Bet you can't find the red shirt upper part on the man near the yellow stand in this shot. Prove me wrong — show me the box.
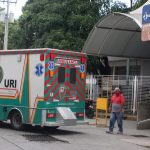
[111,93,125,105]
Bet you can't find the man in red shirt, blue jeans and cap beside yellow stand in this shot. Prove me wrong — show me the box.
[106,87,125,134]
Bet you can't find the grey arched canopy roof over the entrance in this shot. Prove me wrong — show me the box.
[83,10,150,59]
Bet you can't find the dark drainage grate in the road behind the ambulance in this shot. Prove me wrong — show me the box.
[22,134,69,143]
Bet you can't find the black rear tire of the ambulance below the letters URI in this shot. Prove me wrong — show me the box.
[10,111,23,130]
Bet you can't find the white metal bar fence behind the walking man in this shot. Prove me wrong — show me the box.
[86,75,150,113]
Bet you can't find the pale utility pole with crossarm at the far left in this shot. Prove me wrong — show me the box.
[0,0,17,50]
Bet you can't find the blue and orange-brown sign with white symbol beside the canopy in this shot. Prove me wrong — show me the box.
[141,4,150,41]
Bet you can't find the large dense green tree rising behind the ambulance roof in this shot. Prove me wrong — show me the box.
[13,0,110,51]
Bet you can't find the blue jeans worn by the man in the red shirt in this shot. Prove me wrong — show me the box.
[109,112,123,132]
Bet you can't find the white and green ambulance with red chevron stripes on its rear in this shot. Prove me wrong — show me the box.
[0,48,87,130]
